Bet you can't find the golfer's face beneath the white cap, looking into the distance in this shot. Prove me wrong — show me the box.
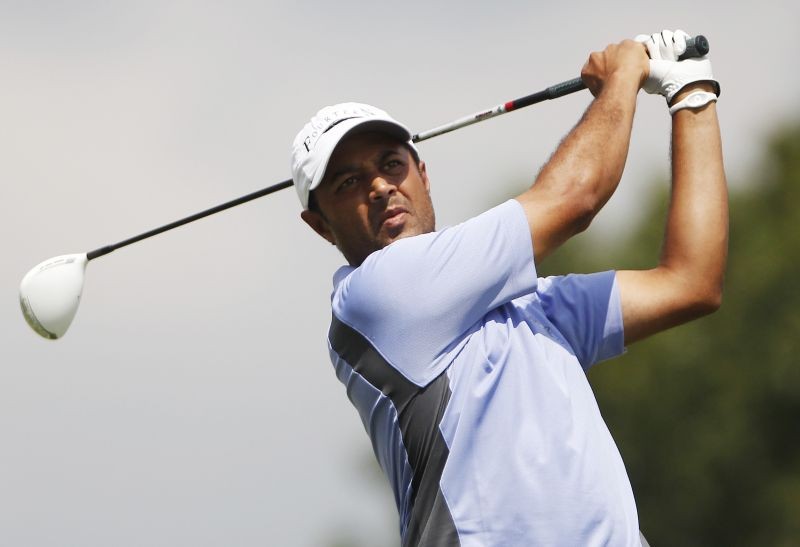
[314,133,434,264]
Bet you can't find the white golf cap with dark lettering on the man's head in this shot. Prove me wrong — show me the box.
[292,103,416,209]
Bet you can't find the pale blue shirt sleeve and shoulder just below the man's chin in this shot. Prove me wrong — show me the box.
[332,200,537,386]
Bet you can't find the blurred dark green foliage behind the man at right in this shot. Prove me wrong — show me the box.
[544,120,800,547]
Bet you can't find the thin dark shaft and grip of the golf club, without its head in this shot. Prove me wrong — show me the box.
[86,35,709,260]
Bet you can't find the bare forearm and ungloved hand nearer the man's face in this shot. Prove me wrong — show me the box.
[516,40,648,261]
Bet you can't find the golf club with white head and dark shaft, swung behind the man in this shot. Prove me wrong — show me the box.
[19,35,709,340]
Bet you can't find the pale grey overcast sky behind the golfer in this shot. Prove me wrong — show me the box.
[0,0,800,547]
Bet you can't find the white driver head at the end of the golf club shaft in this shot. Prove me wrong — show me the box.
[19,254,88,340]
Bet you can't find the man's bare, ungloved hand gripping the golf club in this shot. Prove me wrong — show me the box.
[581,40,648,97]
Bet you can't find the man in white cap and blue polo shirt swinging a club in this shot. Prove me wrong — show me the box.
[292,31,727,547]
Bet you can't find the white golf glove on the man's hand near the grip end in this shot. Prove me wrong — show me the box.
[634,30,720,104]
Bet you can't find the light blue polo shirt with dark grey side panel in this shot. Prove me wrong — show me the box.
[328,200,640,547]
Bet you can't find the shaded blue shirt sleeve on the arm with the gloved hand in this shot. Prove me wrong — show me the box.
[537,271,625,370]
